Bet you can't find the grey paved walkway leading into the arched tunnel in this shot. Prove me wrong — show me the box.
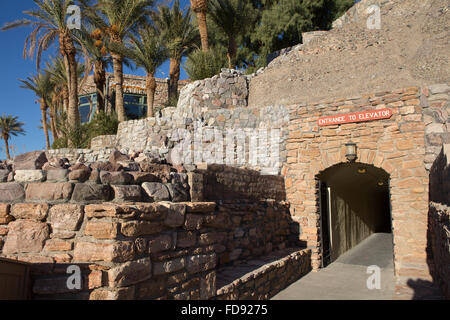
[273,233,395,300]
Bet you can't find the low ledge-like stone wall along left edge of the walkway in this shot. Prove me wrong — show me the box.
[216,248,311,300]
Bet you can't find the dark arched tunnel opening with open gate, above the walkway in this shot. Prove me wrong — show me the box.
[318,163,392,267]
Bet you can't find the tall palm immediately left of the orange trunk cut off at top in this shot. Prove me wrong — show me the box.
[153,0,199,101]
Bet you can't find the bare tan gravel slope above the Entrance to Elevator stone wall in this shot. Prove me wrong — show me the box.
[249,0,450,106]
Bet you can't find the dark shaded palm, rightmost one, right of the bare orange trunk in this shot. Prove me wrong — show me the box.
[209,0,250,69]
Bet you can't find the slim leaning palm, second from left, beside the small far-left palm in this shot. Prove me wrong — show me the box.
[19,71,55,149]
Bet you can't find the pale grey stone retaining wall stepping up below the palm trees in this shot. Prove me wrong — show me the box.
[83,69,289,174]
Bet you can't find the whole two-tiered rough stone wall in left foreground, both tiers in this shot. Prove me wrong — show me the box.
[0,151,309,300]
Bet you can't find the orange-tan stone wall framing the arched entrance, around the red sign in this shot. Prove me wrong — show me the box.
[283,87,430,281]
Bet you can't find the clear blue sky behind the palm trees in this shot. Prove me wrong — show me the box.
[0,0,189,159]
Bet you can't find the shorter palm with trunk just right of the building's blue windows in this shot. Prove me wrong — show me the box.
[118,26,168,118]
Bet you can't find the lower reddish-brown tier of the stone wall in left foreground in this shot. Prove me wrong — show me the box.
[0,198,298,299]
